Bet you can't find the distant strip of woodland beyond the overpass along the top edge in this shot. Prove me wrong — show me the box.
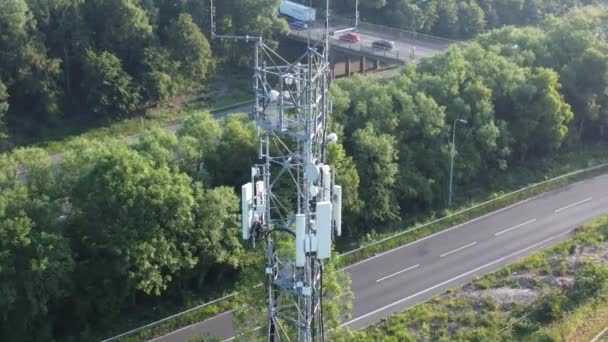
[320,0,600,39]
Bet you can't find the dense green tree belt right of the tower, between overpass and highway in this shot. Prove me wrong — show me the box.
[332,7,608,236]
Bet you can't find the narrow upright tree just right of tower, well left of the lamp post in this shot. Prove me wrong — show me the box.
[352,124,399,230]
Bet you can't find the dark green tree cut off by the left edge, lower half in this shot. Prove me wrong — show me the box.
[0,150,74,341]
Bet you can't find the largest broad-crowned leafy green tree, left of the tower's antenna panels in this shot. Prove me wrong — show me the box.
[68,145,197,322]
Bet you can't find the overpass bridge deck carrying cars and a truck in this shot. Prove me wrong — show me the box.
[288,17,460,65]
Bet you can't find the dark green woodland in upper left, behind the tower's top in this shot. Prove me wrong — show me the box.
[0,0,287,146]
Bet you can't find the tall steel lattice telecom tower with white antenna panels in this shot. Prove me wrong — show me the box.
[211,0,342,342]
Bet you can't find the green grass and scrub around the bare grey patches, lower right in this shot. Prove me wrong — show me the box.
[333,217,608,342]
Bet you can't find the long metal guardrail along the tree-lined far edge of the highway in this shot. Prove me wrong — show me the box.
[102,163,608,342]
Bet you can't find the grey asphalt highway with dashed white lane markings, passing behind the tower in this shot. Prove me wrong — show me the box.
[152,175,608,342]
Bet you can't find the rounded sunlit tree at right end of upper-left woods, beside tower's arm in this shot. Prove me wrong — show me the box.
[167,14,213,85]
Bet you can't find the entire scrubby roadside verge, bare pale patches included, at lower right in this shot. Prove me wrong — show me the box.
[332,217,608,341]
